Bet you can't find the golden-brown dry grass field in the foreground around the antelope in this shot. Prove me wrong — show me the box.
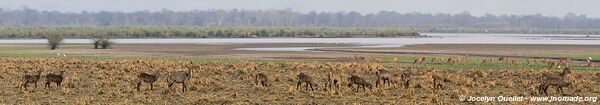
[0,58,600,104]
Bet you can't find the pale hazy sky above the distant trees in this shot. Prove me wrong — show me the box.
[0,0,600,18]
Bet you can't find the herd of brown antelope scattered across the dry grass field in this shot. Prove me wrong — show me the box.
[21,56,594,95]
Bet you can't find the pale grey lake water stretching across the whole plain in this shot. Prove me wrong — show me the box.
[0,33,600,51]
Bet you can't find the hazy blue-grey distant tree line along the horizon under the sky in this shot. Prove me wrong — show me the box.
[0,7,600,30]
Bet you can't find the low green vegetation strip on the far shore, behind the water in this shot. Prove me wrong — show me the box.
[0,26,420,38]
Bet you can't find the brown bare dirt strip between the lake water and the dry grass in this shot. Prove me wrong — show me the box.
[0,43,600,61]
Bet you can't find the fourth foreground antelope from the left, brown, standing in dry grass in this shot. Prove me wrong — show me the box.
[167,69,192,92]
